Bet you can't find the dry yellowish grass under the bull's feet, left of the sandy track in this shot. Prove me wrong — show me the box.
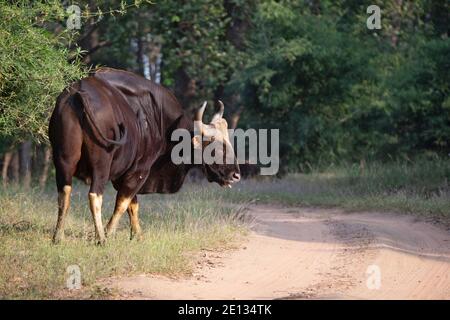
[0,185,245,299]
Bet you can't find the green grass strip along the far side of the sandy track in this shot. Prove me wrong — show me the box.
[225,160,450,223]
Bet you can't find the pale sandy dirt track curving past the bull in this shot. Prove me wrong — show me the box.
[108,206,450,299]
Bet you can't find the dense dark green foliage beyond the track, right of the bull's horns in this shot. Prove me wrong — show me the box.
[234,1,450,170]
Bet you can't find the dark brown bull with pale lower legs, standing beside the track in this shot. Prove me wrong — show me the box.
[49,68,240,243]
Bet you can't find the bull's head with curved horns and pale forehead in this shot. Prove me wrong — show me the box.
[192,101,241,188]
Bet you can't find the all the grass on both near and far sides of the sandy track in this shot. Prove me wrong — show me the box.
[0,160,450,298]
